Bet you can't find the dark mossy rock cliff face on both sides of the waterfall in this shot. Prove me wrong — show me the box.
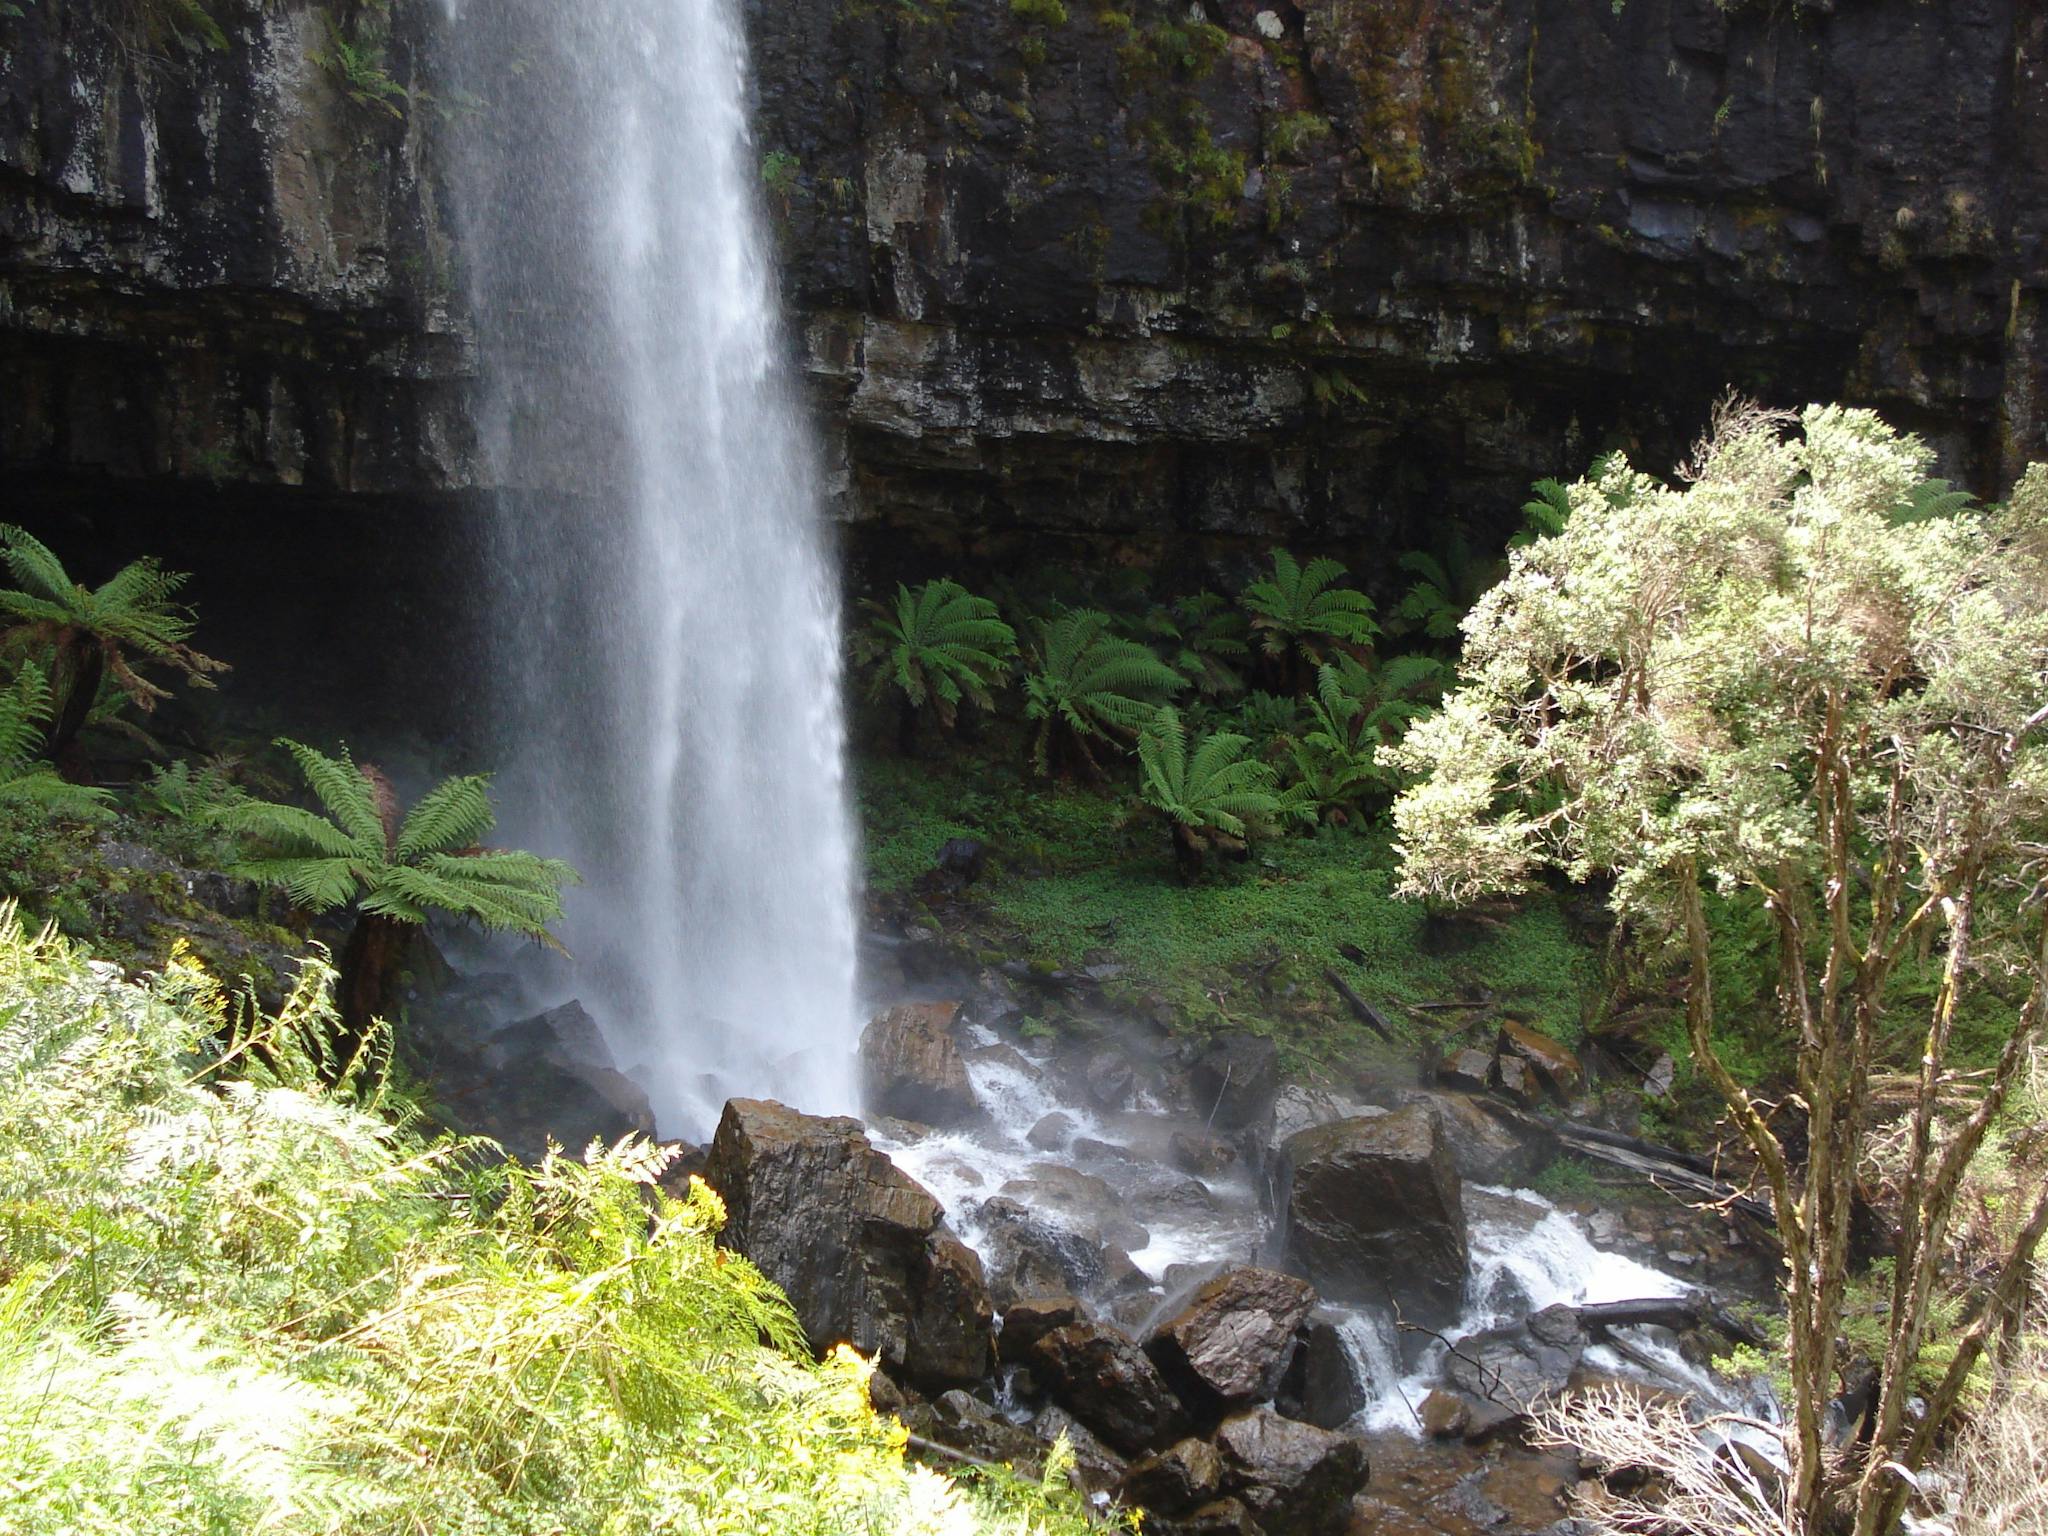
[0,0,2048,555]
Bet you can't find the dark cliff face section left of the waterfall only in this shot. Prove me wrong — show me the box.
[0,0,469,500]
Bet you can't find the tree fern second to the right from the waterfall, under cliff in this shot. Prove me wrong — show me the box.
[1024,608,1186,776]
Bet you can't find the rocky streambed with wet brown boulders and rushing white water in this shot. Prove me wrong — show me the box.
[395,933,1769,1536]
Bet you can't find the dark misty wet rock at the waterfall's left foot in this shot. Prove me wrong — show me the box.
[465,1001,653,1161]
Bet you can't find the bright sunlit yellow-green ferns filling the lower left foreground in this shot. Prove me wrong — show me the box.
[0,905,1100,1536]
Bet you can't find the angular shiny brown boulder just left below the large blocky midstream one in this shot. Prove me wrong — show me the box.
[1145,1268,1315,1419]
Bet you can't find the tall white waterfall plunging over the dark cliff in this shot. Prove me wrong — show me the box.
[442,0,856,1137]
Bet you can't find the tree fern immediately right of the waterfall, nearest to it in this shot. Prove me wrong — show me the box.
[856,580,1018,729]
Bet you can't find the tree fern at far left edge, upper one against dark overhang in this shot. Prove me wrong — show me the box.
[0,524,225,758]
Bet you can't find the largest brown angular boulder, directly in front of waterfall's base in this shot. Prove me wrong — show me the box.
[705,1098,995,1391]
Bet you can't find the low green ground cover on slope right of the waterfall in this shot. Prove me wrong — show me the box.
[858,758,1597,1065]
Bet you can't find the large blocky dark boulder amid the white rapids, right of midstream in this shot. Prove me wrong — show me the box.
[1280,1102,1468,1327]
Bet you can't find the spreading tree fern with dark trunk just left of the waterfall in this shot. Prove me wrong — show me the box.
[221,739,575,1034]
